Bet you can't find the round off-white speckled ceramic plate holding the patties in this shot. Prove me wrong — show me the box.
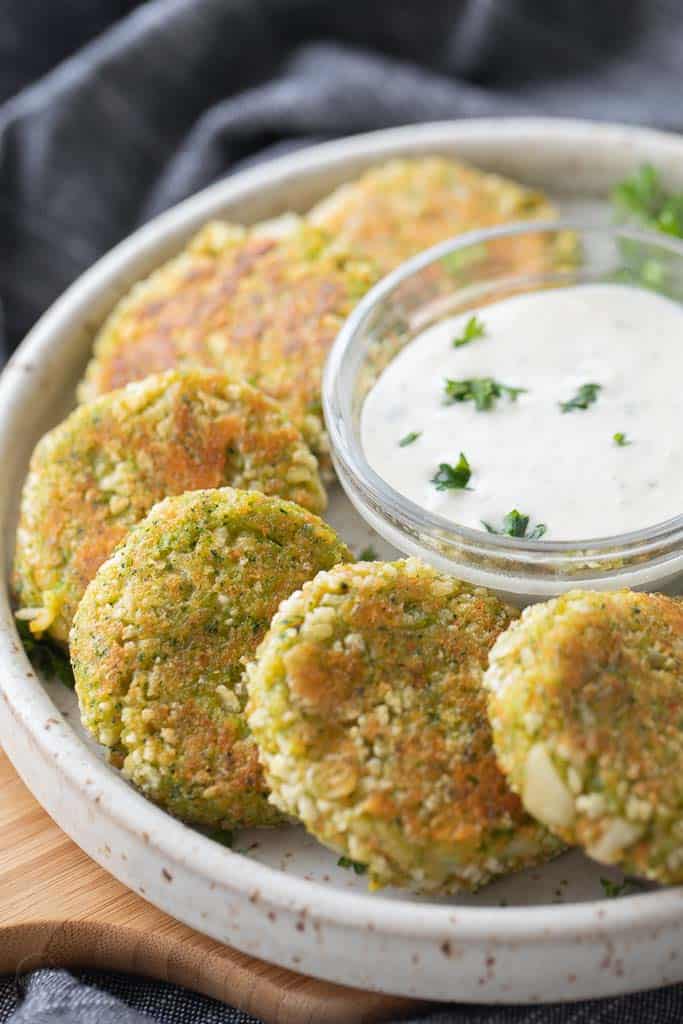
[0,119,683,1002]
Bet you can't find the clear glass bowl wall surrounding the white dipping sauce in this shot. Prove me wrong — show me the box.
[323,221,683,604]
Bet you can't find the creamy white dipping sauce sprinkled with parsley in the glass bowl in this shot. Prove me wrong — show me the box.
[361,285,683,540]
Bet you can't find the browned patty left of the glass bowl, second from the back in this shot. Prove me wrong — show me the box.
[80,222,378,468]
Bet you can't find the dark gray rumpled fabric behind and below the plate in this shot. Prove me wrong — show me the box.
[0,0,683,1024]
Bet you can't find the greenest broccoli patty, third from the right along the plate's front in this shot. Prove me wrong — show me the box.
[71,487,350,828]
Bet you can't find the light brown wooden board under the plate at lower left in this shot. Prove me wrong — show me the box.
[0,751,426,1024]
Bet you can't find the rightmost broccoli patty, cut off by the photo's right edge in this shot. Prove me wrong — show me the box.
[485,590,683,883]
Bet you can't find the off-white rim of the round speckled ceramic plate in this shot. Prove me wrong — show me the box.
[0,118,683,995]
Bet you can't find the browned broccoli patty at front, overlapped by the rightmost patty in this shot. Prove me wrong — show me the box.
[248,558,560,892]
